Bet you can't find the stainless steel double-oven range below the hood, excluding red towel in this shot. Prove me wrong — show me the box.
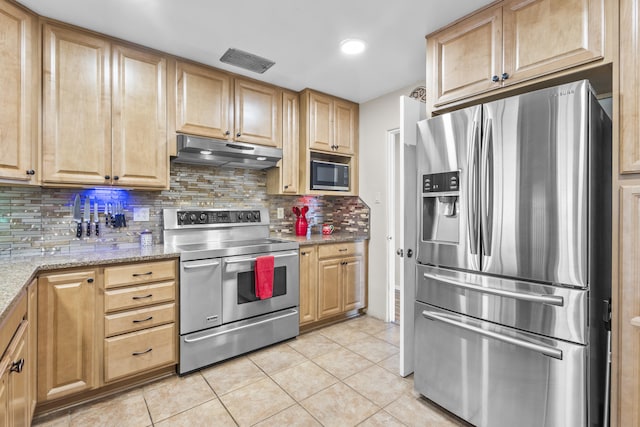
[163,209,299,374]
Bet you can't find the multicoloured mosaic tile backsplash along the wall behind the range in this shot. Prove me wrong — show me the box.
[0,164,369,257]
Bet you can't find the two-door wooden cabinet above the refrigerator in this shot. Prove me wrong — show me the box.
[427,0,613,108]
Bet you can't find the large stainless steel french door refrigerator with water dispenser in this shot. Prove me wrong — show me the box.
[414,80,611,427]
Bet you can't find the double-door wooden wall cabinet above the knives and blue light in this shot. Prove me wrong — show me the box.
[42,23,169,188]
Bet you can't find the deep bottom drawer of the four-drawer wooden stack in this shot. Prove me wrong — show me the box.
[104,323,176,382]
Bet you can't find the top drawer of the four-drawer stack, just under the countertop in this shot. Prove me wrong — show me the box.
[104,261,176,288]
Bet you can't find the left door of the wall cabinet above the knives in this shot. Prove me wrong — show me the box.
[42,24,111,185]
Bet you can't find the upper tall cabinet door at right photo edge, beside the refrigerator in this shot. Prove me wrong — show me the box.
[618,0,640,173]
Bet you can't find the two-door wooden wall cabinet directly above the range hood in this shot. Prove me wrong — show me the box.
[175,61,282,147]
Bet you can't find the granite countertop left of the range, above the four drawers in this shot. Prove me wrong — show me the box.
[0,245,180,323]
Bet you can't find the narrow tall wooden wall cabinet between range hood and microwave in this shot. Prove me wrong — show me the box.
[267,91,300,194]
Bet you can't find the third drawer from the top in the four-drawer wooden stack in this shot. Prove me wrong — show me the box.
[104,303,176,337]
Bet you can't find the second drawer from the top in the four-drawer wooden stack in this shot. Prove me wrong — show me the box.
[104,280,176,313]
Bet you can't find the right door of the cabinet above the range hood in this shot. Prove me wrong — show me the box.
[233,79,282,147]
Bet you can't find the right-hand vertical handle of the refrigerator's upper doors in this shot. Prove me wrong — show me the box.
[480,119,493,256]
